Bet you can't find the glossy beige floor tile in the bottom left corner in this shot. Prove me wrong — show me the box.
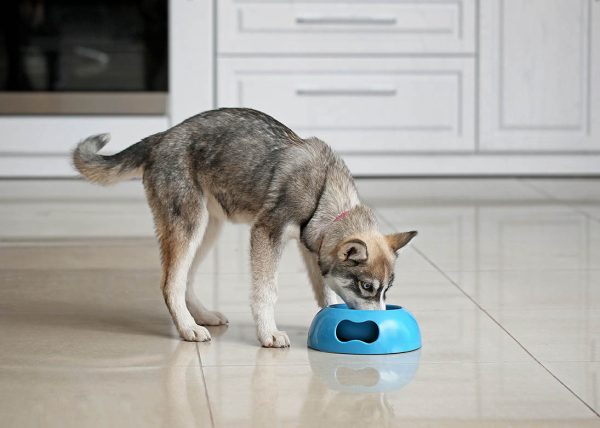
[0,348,212,428]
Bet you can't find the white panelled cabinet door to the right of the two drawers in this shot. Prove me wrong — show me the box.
[480,0,600,152]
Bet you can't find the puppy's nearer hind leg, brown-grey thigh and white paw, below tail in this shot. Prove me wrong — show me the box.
[144,172,210,342]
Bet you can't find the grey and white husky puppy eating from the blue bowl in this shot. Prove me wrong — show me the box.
[73,108,417,348]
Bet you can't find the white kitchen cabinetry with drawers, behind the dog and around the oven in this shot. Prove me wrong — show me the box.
[0,0,600,176]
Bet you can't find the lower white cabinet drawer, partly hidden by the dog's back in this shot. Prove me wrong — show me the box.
[218,58,474,153]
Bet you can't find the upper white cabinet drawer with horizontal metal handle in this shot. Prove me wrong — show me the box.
[217,0,475,54]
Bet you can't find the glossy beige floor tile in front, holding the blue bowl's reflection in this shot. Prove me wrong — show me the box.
[204,362,598,427]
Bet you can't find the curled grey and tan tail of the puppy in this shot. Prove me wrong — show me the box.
[73,134,150,186]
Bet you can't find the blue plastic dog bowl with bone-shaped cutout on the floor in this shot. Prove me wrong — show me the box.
[308,304,421,355]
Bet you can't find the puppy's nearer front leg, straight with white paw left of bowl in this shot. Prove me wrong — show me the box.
[250,224,290,348]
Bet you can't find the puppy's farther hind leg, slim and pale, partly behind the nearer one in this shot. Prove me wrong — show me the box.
[185,215,228,325]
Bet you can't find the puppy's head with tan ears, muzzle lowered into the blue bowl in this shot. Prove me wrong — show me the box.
[323,230,417,310]
